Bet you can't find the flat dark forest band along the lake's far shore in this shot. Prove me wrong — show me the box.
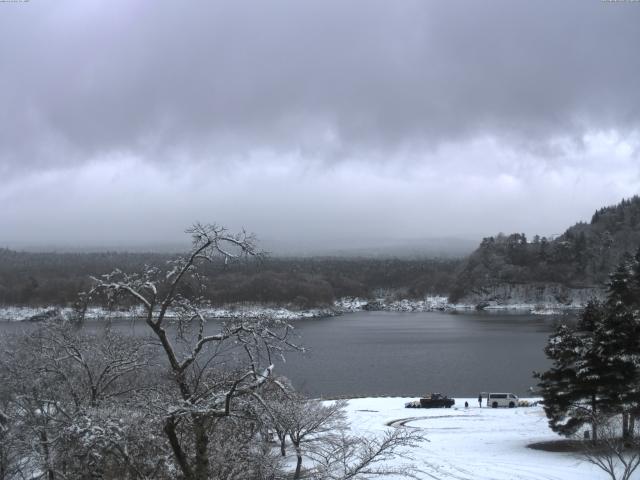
[0,249,461,307]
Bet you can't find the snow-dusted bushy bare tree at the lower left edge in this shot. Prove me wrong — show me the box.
[0,323,155,480]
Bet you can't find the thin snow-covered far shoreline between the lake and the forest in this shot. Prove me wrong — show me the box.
[0,296,583,321]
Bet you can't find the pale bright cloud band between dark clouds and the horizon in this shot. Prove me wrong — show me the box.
[0,136,640,252]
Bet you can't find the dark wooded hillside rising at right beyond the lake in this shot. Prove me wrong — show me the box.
[451,196,640,301]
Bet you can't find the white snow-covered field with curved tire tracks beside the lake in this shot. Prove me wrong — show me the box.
[348,398,604,480]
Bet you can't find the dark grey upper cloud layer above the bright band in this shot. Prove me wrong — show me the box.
[0,0,640,174]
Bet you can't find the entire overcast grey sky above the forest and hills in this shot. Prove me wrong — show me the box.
[0,0,640,250]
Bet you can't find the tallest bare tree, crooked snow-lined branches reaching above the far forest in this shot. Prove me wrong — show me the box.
[83,224,293,480]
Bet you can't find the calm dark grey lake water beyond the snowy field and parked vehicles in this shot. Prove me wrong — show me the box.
[0,312,558,397]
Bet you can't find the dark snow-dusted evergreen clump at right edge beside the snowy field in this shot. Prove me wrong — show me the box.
[536,250,640,440]
